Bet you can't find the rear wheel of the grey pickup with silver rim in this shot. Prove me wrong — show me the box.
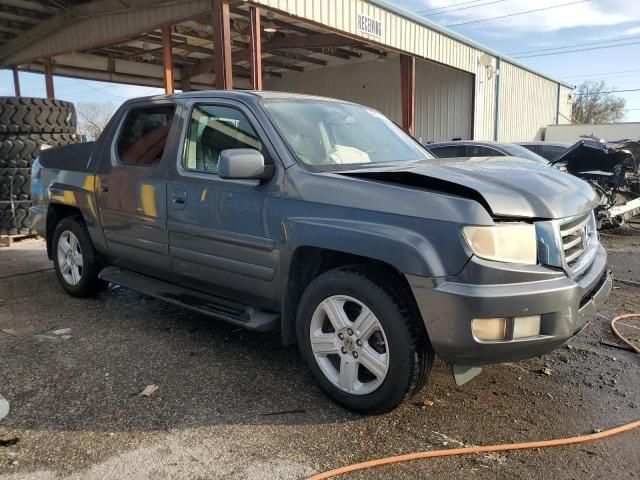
[52,217,104,297]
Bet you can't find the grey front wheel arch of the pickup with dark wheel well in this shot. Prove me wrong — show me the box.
[280,219,443,345]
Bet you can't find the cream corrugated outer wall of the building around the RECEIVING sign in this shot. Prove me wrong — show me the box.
[253,0,571,141]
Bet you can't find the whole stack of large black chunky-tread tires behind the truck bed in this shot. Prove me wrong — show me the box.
[0,97,80,235]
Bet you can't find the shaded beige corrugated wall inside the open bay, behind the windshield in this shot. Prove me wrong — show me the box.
[265,56,474,141]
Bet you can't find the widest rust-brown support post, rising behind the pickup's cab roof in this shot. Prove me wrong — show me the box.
[212,0,233,90]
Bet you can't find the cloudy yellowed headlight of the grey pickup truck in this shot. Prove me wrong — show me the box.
[463,224,538,265]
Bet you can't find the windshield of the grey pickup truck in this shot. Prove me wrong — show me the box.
[264,99,433,169]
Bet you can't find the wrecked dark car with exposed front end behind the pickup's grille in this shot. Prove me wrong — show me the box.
[552,138,640,228]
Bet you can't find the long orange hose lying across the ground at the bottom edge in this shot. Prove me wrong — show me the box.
[308,420,640,480]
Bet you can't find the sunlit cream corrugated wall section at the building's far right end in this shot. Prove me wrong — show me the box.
[498,61,558,142]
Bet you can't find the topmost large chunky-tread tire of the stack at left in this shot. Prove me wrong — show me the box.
[0,97,78,133]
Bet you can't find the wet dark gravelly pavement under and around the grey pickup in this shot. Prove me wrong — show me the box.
[0,229,640,480]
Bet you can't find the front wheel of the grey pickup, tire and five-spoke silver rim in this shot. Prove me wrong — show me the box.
[296,267,433,413]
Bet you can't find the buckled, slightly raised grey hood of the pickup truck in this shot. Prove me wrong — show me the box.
[335,157,598,219]
